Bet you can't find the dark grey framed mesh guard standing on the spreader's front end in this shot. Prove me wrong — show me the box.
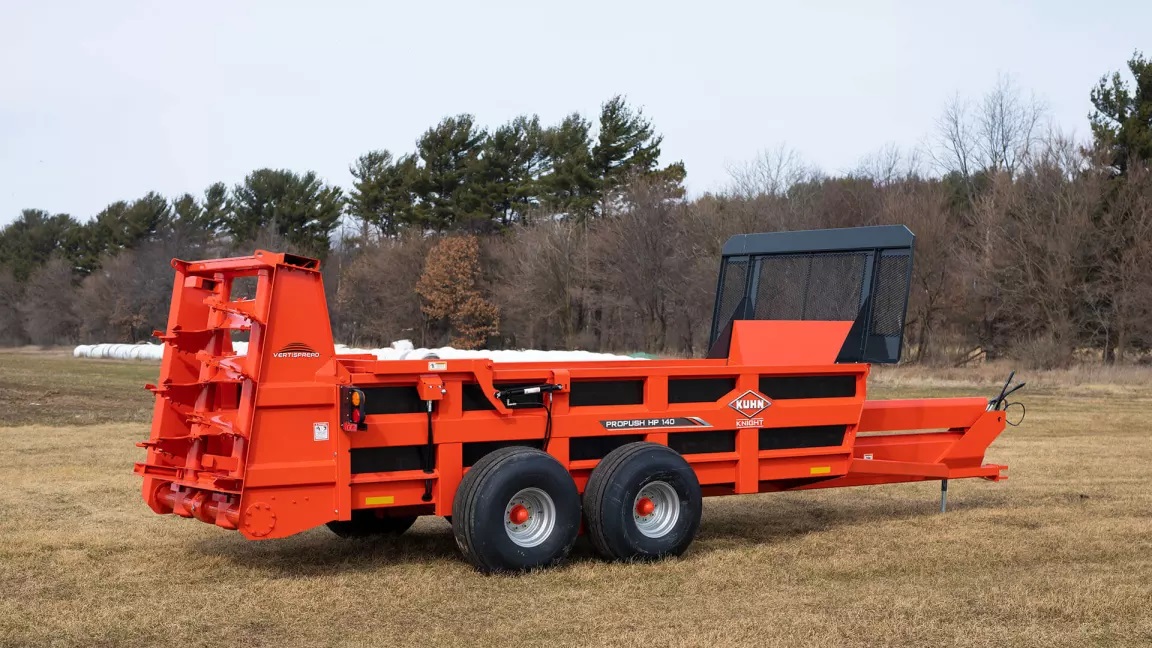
[708,226,915,364]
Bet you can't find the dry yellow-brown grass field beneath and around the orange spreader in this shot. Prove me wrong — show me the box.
[0,352,1152,647]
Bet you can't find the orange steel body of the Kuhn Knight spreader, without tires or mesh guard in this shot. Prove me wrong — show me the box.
[136,251,1006,538]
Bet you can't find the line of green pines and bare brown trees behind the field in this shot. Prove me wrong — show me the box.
[0,53,1152,366]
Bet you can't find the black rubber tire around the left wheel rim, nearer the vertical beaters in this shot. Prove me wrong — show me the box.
[452,446,581,573]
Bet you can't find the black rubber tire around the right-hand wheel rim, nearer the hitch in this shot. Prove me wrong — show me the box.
[584,442,703,560]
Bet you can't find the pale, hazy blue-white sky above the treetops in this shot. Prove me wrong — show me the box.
[0,0,1152,224]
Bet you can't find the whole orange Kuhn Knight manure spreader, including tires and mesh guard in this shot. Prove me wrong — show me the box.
[136,226,1009,572]
